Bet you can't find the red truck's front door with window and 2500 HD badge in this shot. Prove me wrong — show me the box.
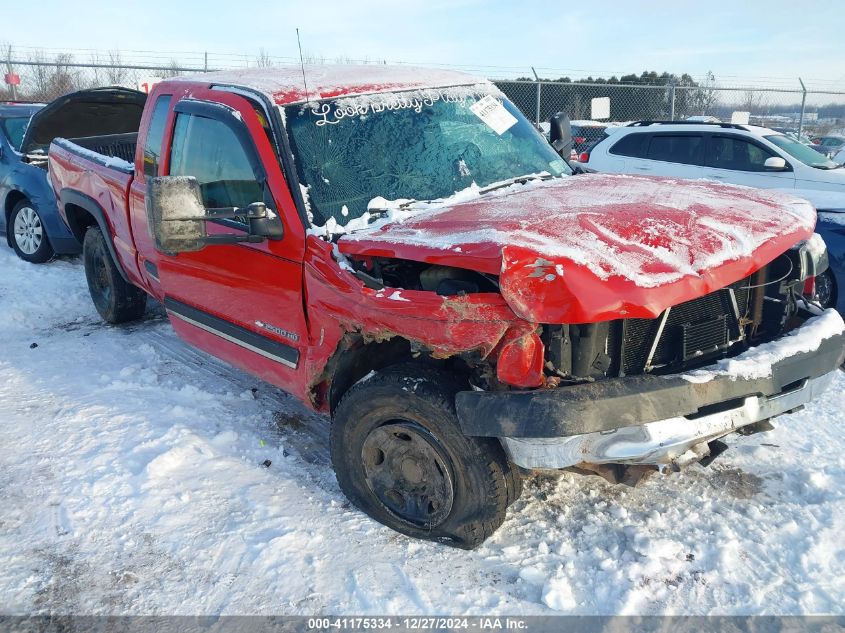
[142,90,308,389]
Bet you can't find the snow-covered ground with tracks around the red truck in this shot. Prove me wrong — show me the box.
[0,248,845,615]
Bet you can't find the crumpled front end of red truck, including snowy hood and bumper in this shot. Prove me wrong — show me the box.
[312,172,845,479]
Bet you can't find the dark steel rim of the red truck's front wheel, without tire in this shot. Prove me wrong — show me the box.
[361,421,455,529]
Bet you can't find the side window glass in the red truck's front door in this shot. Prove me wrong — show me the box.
[170,114,264,209]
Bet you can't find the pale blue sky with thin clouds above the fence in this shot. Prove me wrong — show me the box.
[0,0,845,89]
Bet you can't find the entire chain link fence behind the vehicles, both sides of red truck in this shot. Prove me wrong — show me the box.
[0,46,845,135]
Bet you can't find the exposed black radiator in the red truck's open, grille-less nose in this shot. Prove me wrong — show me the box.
[621,279,750,375]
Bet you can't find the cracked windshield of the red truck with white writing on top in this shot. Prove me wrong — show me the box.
[285,85,571,226]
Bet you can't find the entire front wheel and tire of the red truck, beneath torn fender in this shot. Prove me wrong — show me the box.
[331,365,522,549]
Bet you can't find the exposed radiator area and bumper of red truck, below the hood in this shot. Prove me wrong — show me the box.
[457,235,845,476]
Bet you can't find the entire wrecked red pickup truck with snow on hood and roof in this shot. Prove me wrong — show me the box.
[49,66,845,547]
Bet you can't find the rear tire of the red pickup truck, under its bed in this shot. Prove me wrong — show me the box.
[82,226,147,324]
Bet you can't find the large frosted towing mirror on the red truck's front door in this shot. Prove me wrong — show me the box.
[146,176,284,253]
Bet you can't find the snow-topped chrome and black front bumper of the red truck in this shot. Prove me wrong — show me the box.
[456,310,845,468]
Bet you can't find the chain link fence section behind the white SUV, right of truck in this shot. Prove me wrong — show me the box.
[496,81,845,135]
